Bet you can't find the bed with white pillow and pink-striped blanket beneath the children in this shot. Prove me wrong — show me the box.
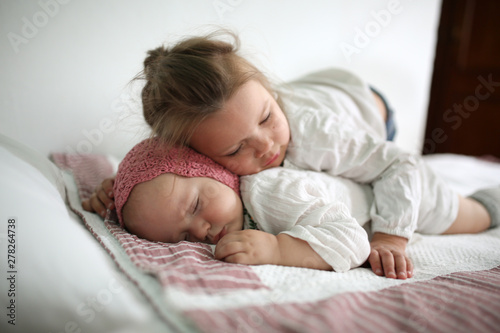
[0,131,500,332]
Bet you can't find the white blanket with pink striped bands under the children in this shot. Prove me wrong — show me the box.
[53,154,500,332]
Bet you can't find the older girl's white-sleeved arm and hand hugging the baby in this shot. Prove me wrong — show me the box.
[292,126,423,279]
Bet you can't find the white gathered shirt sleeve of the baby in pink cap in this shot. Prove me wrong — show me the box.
[241,168,370,272]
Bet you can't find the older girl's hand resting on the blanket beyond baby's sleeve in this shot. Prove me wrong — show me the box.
[368,232,413,280]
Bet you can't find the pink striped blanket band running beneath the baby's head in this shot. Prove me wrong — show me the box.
[52,154,266,294]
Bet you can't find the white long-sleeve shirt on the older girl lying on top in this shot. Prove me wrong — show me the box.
[278,69,422,238]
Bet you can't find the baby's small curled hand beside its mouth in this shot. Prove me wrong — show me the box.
[215,230,281,265]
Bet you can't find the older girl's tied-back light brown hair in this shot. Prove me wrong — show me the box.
[138,31,273,147]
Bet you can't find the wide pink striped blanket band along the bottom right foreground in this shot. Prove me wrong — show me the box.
[186,267,500,332]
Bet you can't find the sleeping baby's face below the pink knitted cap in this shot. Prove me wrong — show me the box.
[123,173,243,244]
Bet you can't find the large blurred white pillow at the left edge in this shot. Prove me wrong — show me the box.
[0,135,169,332]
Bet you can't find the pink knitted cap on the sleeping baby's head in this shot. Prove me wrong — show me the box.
[113,138,240,227]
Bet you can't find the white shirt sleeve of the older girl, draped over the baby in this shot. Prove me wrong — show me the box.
[290,117,422,238]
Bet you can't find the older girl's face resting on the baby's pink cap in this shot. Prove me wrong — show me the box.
[190,80,290,176]
